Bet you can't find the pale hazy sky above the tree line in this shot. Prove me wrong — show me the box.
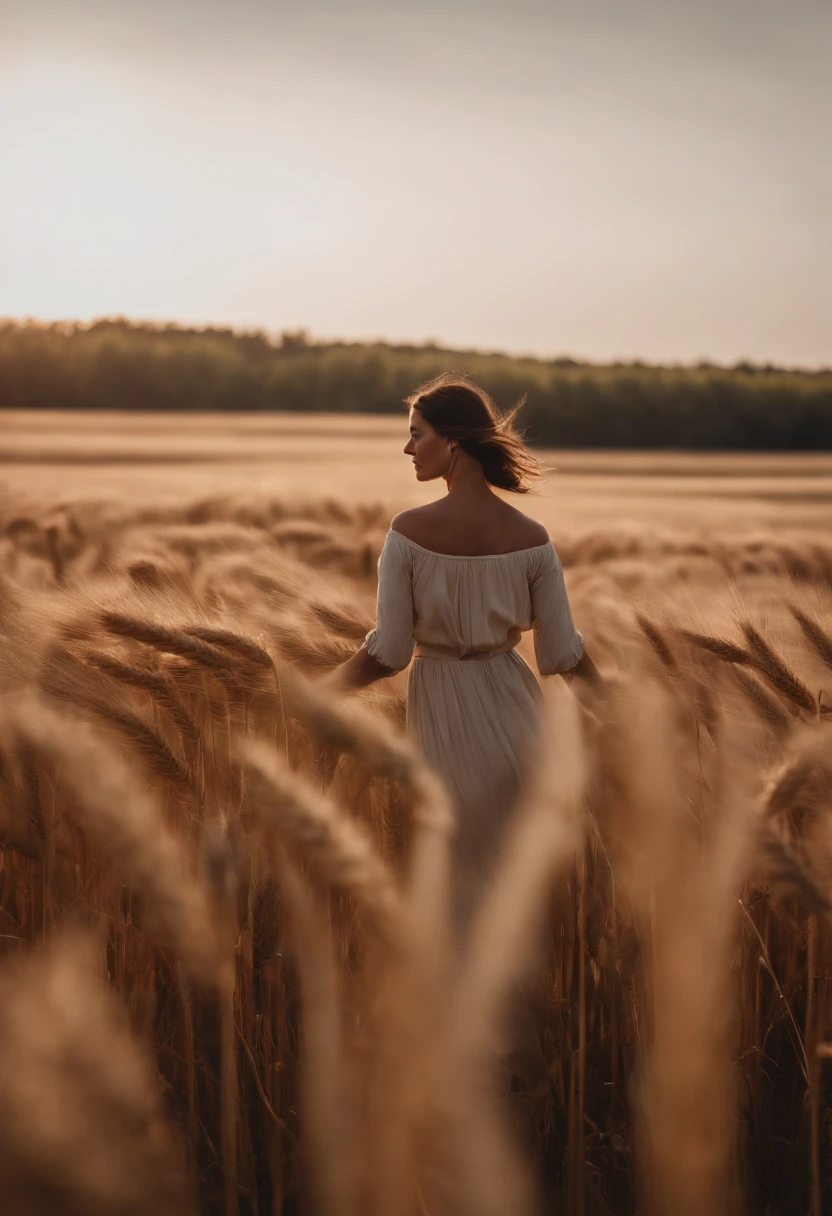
[0,0,832,366]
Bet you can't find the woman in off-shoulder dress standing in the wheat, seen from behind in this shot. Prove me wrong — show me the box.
[335,375,597,927]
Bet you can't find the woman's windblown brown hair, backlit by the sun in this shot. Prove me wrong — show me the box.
[405,372,541,494]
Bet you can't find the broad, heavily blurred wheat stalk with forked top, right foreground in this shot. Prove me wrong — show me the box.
[617,688,754,1216]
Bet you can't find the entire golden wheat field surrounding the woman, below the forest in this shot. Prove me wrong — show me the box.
[0,411,832,1216]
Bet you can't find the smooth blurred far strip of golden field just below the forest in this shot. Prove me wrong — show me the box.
[0,410,832,525]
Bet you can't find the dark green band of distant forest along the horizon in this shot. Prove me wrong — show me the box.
[0,319,832,451]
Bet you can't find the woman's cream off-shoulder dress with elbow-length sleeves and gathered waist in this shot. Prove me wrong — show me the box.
[365,529,584,923]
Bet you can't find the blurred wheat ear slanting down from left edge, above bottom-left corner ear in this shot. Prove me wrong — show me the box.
[0,698,229,985]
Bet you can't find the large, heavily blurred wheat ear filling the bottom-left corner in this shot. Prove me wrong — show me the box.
[0,933,196,1216]
